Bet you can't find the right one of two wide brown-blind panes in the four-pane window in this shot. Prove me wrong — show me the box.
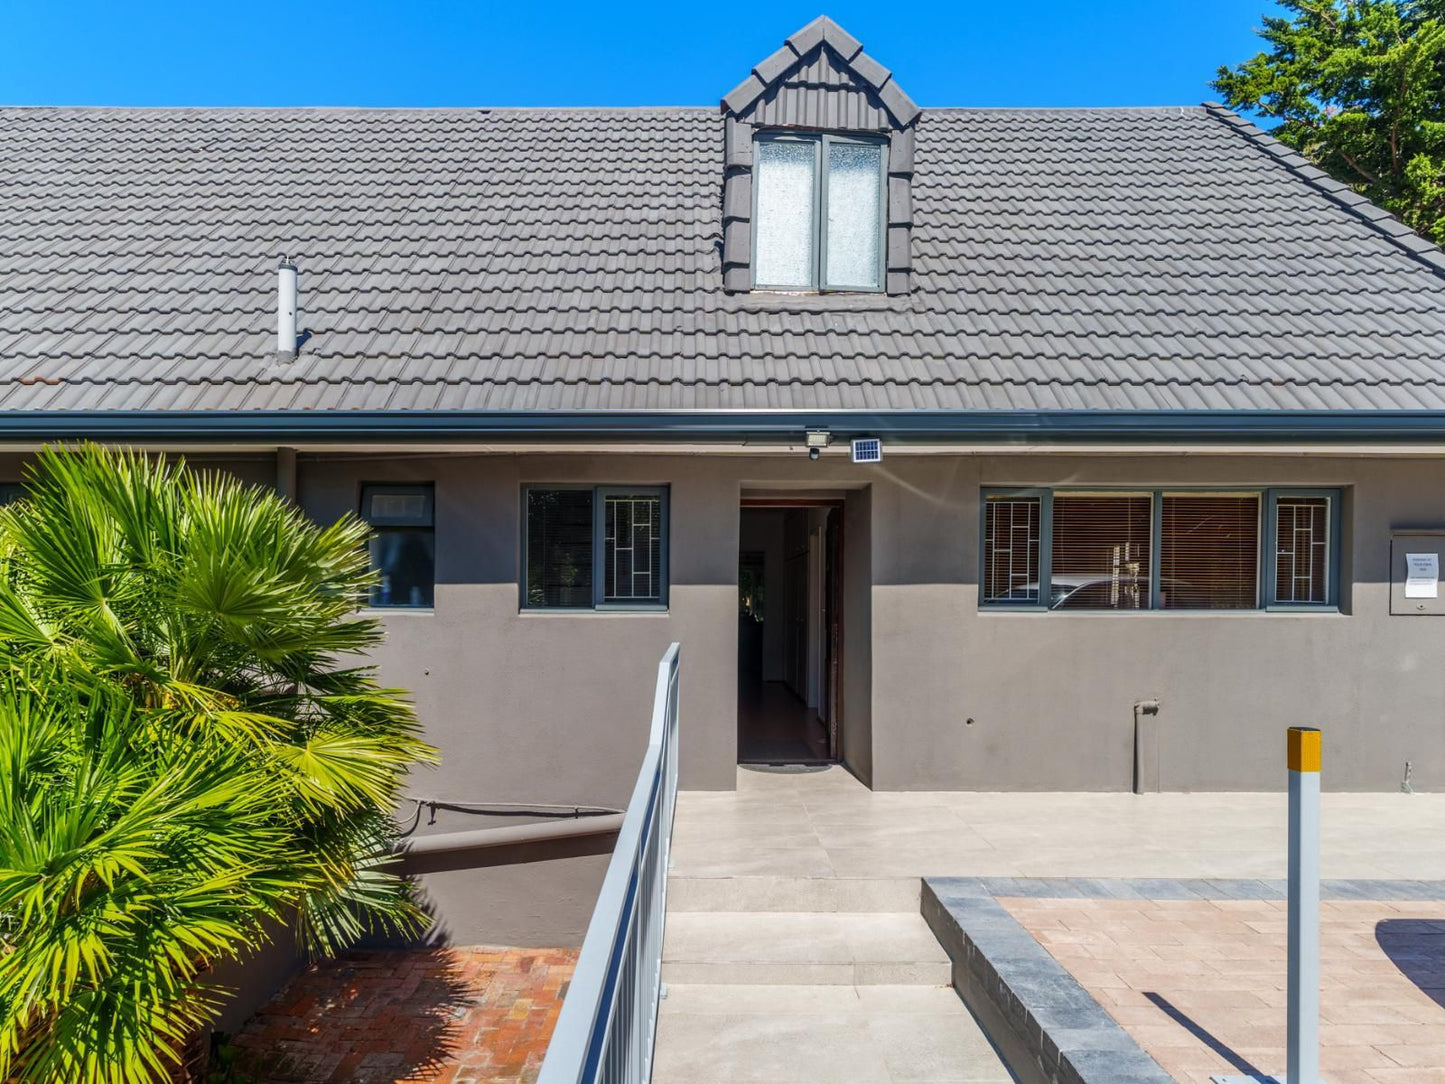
[1159,494,1260,610]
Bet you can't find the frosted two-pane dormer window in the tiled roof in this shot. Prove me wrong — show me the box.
[753,132,887,291]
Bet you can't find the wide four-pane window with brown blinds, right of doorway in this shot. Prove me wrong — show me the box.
[980,489,1338,610]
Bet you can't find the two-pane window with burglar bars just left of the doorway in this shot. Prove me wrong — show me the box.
[523,486,668,610]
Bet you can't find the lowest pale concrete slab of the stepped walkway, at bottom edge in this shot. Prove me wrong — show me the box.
[652,984,1013,1084]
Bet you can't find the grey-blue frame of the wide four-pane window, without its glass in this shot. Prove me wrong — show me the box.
[978,486,1342,617]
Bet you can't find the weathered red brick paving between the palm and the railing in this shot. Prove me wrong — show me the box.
[234,947,577,1084]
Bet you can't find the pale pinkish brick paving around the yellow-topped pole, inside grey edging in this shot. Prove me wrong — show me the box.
[998,898,1445,1084]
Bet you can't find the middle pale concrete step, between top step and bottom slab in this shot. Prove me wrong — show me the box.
[662,911,952,986]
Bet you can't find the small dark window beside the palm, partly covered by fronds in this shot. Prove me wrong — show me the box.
[361,484,436,607]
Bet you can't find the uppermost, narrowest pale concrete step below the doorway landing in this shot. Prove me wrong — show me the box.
[668,876,920,915]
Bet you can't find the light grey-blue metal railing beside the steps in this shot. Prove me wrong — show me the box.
[538,643,679,1084]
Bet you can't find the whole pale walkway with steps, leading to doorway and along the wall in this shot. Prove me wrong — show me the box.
[656,767,1445,1084]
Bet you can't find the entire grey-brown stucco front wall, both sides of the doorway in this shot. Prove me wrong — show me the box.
[290,455,1445,804]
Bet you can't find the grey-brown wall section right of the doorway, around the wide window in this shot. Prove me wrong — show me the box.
[873,455,1445,791]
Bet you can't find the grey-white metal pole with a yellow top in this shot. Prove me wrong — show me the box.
[1285,727,1321,1084]
